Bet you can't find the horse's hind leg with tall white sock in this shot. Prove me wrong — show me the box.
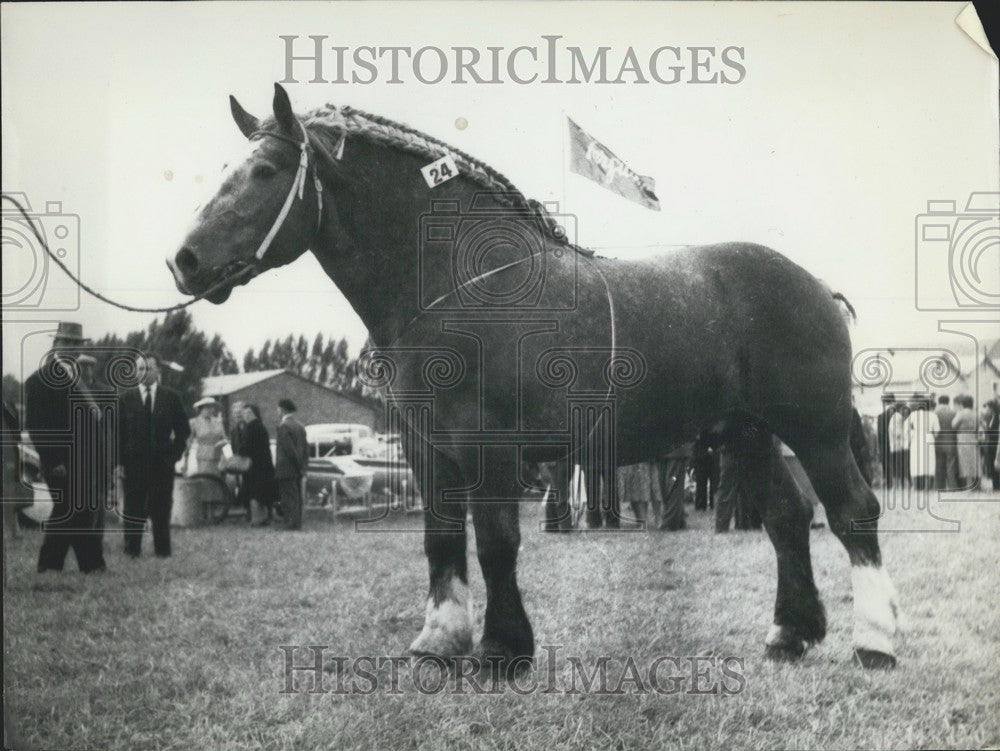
[796,438,901,667]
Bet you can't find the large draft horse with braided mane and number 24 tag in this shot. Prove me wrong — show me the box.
[167,84,901,668]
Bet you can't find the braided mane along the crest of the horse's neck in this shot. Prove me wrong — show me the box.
[305,104,593,256]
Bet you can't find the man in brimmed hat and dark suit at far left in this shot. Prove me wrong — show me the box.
[24,321,113,573]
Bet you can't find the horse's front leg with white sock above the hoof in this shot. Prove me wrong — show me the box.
[410,453,472,657]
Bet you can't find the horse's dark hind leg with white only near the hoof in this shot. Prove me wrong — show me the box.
[726,425,826,660]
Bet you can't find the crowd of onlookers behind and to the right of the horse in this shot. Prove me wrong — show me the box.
[541,394,1000,532]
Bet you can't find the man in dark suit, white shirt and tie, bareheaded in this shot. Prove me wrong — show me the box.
[118,354,191,558]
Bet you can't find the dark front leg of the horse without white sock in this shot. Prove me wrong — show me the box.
[471,452,535,670]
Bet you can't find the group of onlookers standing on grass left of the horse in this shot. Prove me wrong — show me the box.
[3,322,309,573]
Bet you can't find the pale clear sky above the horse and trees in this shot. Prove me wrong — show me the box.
[0,2,1000,388]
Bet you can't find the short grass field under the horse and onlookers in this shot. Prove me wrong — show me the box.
[4,495,1000,751]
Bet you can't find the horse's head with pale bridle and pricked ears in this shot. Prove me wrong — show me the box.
[167,84,328,303]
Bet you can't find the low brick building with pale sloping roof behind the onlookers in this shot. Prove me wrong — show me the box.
[202,370,381,436]
